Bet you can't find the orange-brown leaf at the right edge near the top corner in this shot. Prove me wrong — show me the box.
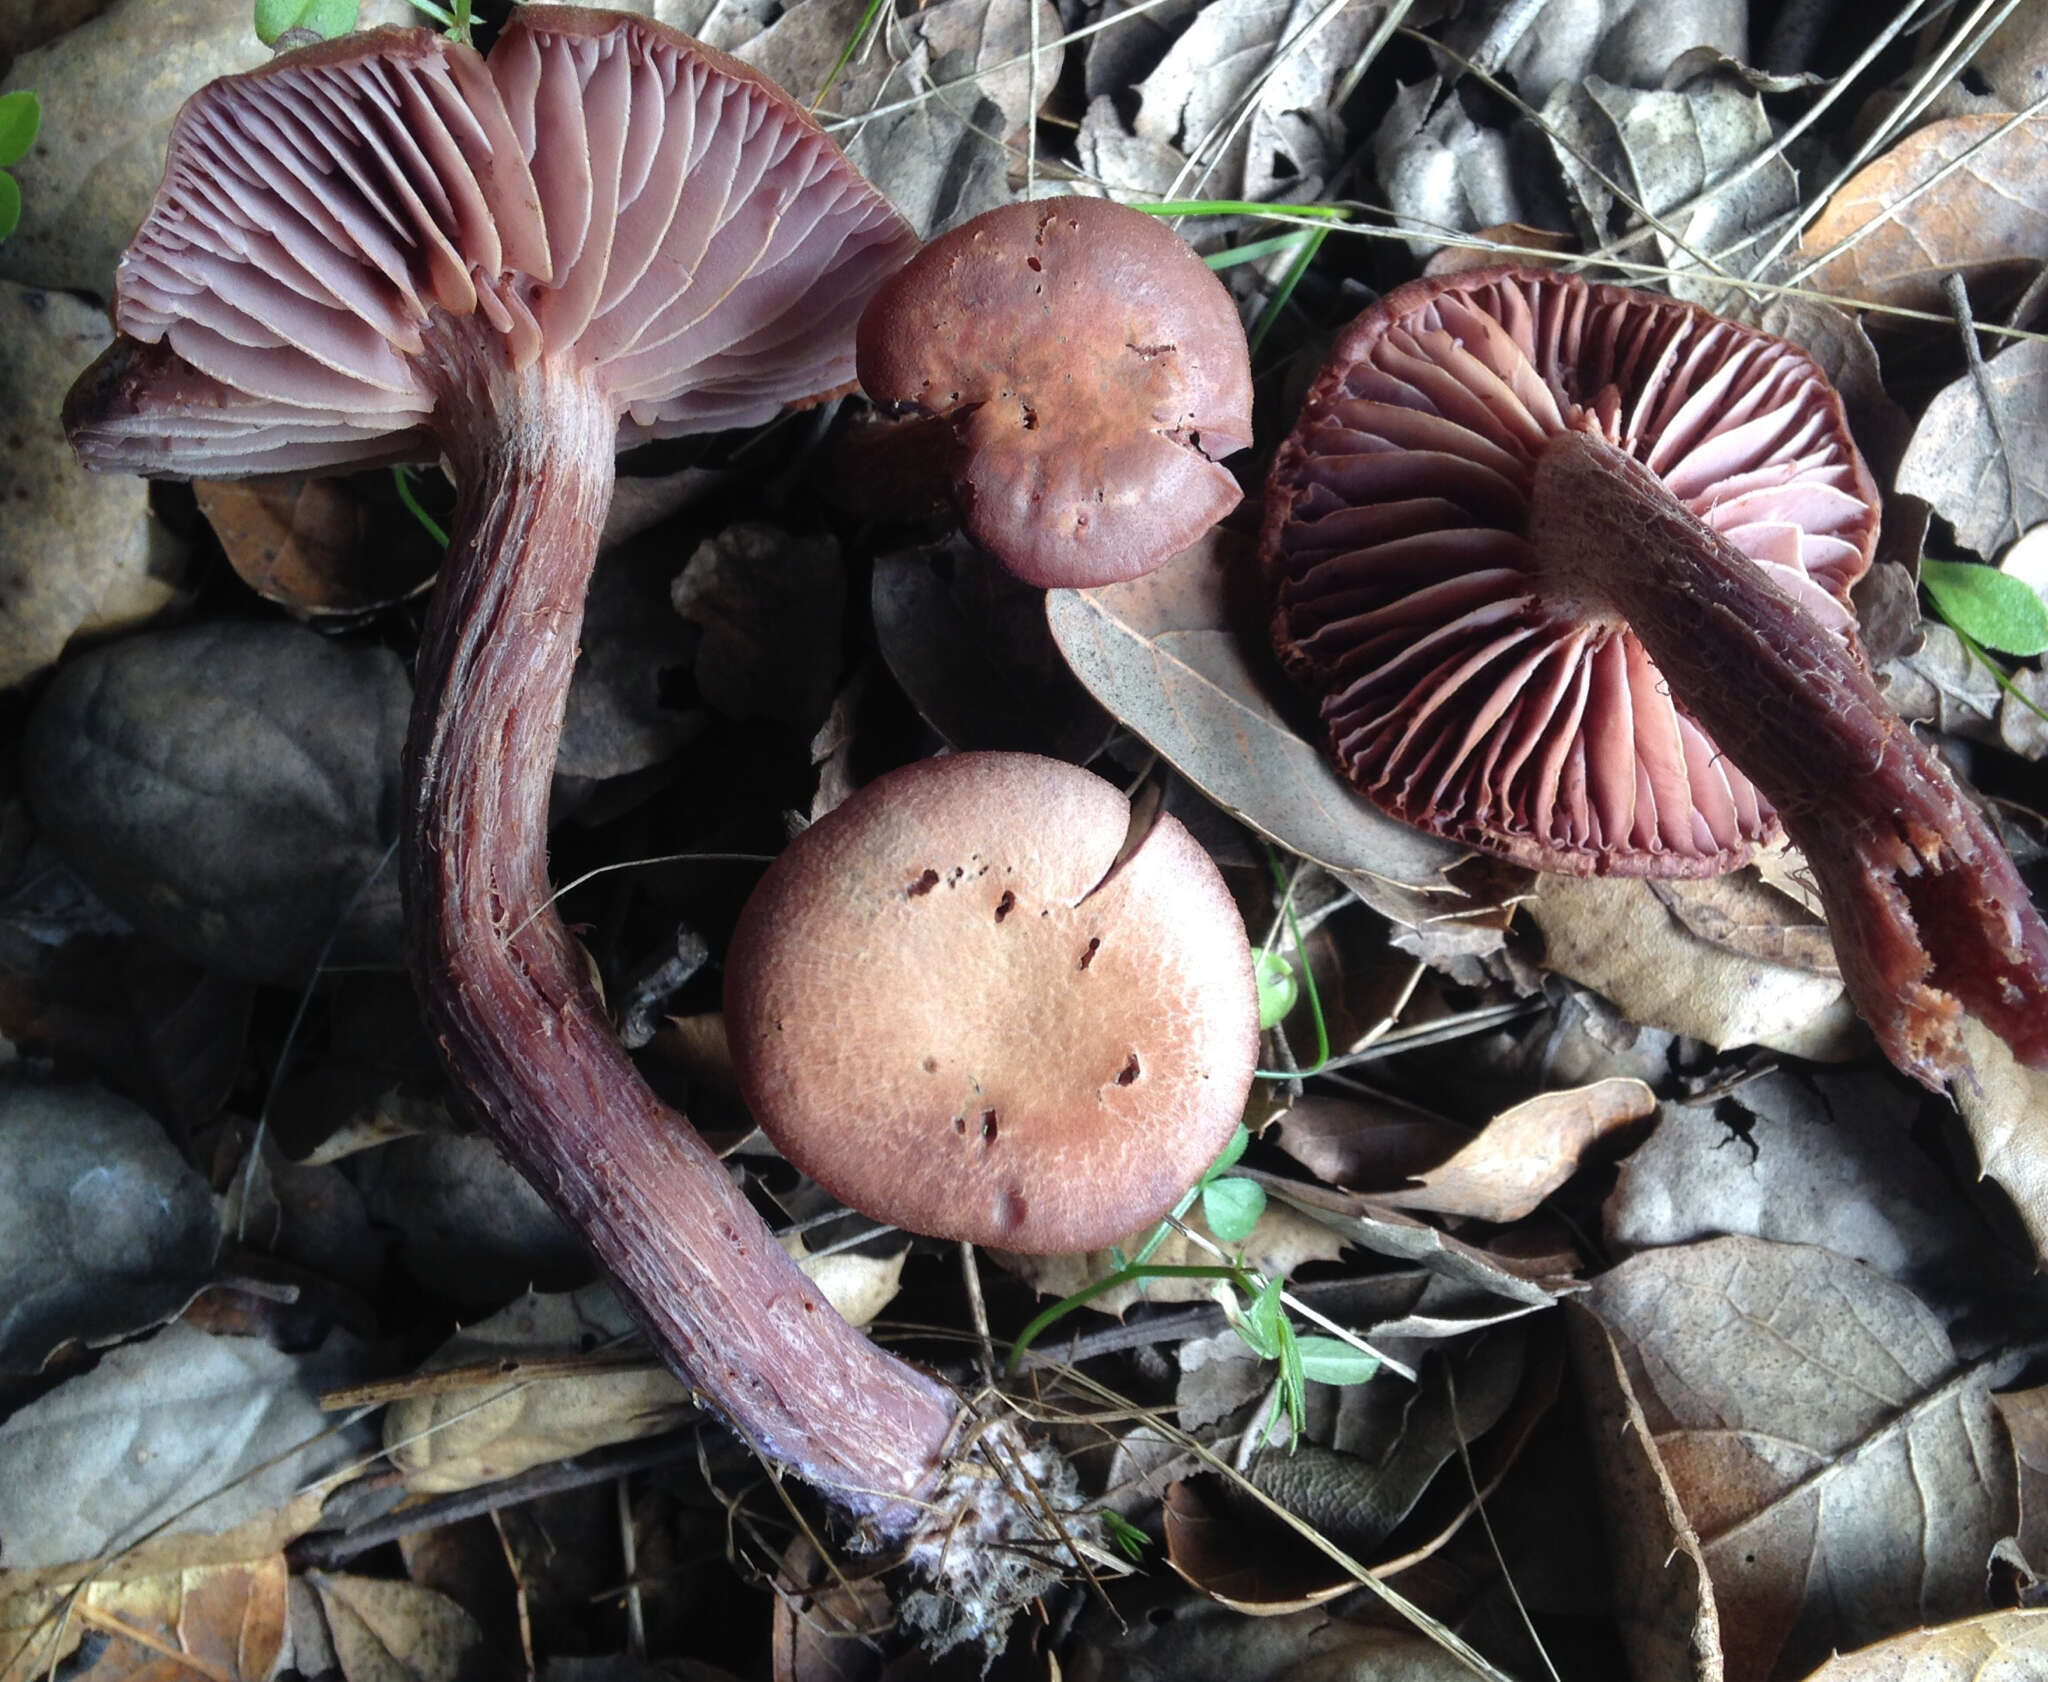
[1798,117,2048,309]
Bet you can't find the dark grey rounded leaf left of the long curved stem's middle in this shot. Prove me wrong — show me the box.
[23,623,412,981]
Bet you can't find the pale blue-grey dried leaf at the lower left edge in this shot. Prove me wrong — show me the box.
[0,1323,362,1567]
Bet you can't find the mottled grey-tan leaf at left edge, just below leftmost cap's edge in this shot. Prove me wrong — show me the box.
[0,282,182,688]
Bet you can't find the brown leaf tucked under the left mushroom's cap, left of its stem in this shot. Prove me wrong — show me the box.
[193,477,440,619]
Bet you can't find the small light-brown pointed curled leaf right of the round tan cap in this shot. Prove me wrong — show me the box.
[1384,1080,1657,1225]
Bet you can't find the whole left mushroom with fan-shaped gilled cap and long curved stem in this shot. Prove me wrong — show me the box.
[68,6,1042,1594]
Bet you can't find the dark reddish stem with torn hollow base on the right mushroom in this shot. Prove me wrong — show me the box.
[1530,432,2048,1088]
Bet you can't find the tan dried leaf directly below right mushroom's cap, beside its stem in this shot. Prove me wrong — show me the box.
[1528,877,1866,1061]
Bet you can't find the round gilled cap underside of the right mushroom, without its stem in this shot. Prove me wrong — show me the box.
[1260,268,1878,877]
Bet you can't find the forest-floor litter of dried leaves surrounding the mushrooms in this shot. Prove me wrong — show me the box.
[12,0,2048,1682]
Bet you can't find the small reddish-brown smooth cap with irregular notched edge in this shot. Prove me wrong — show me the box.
[860,199,1251,586]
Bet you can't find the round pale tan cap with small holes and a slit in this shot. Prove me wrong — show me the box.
[725,754,1260,1254]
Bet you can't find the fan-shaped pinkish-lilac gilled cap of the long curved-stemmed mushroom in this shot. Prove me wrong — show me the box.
[66,6,918,477]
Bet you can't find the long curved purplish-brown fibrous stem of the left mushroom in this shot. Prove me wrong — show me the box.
[403,350,958,1537]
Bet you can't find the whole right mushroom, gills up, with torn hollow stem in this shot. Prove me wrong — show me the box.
[1260,268,2048,1086]
